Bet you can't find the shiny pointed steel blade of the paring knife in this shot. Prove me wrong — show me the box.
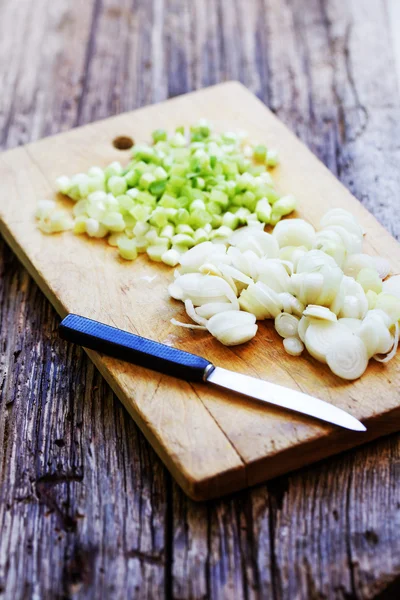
[206,367,367,431]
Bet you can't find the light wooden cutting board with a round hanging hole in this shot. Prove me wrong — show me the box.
[0,82,400,500]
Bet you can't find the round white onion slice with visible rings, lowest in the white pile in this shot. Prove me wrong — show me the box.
[326,332,368,381]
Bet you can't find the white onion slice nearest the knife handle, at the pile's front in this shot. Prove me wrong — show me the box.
[207,311,258,346]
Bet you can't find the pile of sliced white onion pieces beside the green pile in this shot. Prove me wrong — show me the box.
[169,208,400,380]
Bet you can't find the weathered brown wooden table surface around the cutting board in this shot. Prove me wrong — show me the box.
[0,0,400,600]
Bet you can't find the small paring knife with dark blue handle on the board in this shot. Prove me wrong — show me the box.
[59,314,366,431]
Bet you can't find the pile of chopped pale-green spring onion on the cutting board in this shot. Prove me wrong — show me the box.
[36,120,296,262]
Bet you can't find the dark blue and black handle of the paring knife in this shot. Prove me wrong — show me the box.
[59,314,214,381]
